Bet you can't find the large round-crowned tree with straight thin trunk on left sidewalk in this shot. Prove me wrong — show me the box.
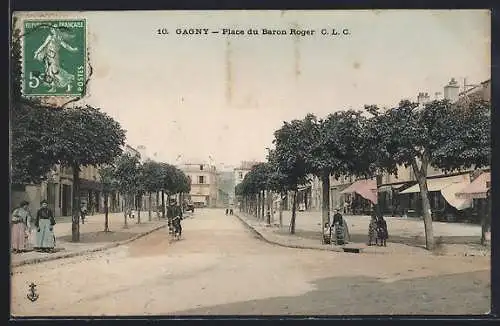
[47,106,125,242]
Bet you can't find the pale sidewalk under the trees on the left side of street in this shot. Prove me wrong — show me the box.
[11,211,166,267]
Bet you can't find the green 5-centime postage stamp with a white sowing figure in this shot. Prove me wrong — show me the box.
[23,19,87,97]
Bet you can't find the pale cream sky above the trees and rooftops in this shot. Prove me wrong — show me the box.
[15,10,490,165]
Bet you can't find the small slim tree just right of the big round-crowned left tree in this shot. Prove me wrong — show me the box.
[114,153,140,228]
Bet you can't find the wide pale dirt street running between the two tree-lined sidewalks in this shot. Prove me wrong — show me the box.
[11,209,490,316]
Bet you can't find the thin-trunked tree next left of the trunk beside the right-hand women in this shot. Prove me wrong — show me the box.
[273,114,315,234]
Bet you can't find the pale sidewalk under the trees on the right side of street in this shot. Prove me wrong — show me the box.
[235,212,490,256]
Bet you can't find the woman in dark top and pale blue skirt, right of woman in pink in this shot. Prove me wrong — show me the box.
[35,200,56,252]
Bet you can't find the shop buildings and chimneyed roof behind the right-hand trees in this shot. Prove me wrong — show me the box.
[285,78,491,220]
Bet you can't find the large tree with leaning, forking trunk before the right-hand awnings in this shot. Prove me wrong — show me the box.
[367,100,491,250]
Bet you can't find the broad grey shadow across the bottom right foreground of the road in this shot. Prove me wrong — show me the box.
[173,271,491,315]
